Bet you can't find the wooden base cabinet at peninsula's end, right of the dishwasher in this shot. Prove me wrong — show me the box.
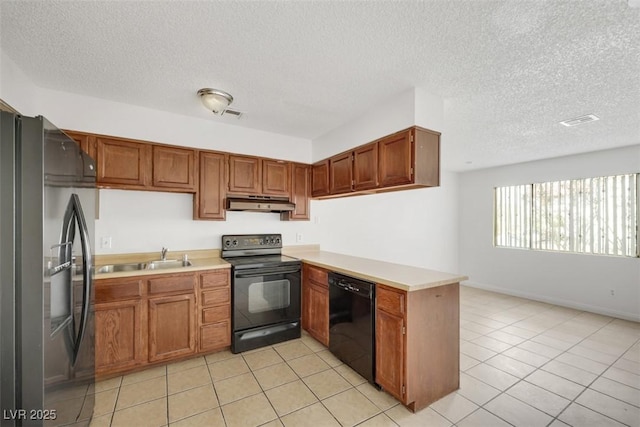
[376,283,460,412]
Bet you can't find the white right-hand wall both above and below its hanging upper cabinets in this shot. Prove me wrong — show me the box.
[312,89,459,273]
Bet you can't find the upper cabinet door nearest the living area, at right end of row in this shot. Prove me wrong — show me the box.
[378,129,414,187]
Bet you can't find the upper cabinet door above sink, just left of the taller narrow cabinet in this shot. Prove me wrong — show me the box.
[152,145,196,191]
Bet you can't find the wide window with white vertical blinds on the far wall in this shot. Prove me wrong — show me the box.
[494,174,639,257]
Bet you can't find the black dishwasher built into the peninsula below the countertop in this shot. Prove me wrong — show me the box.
[329,273,376,384]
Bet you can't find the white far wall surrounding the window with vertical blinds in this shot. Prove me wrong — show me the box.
[459,145,640,320]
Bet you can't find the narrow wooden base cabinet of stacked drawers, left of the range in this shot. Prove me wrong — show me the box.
[198,269,231,352]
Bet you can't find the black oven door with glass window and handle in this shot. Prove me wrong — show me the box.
[232,264,300,331]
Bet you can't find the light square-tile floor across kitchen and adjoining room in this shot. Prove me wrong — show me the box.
[91,287,640,427]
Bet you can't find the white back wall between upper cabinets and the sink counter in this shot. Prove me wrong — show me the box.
[96,190,319,257]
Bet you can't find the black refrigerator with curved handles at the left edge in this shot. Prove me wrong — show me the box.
[0,112,97,426]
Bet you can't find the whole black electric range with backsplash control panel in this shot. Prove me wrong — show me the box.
[222,234,302,353]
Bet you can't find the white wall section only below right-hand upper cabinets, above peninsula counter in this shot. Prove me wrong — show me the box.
[313,172,464,273]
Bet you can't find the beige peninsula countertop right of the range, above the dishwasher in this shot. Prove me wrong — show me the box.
[282,247,468,292]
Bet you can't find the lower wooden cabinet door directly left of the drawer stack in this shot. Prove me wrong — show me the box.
[149,294,196,361]
